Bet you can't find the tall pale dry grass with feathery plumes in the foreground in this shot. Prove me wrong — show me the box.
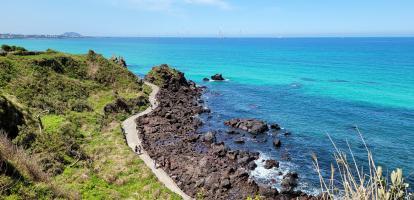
[312,129,412,200]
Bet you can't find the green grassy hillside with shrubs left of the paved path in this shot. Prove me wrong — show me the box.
[0,45,180,199]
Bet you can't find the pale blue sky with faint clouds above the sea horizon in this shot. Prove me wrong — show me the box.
[0,0,414,37]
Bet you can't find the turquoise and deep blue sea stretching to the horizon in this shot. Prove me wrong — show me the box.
[0,38,414,190]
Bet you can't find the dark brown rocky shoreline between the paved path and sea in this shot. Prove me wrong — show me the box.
[136,65,317,199]
